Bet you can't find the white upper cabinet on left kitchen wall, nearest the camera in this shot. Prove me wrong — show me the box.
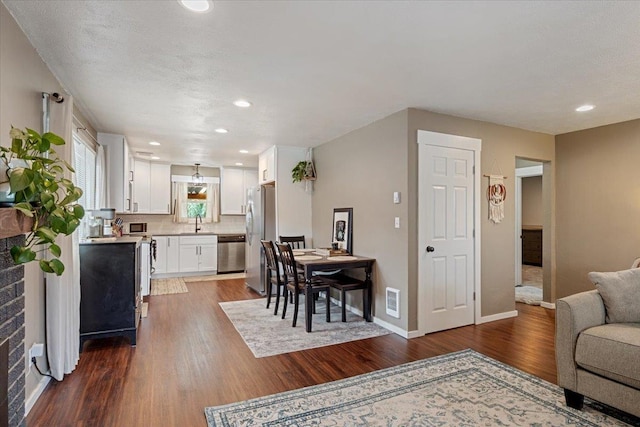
[98,132,133,212]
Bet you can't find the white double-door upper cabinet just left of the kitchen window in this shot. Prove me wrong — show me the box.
[133,159,171,214]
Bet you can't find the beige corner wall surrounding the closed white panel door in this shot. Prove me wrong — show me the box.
[313,109,555,331]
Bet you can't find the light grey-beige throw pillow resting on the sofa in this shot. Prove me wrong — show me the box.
[589,268,640,323]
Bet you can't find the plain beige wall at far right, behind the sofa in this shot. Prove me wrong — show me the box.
[556,120,640,298]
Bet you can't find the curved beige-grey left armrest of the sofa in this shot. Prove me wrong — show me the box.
[556,290,605,391]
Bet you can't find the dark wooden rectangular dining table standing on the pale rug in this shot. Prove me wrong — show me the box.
[294,251,376,332]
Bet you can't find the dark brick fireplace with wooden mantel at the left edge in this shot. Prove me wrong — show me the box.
[0,209,29,427]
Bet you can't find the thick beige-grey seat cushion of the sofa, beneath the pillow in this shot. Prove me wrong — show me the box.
[576,323,640,389]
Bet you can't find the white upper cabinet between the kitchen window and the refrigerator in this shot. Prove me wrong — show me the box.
[220,168,258,215]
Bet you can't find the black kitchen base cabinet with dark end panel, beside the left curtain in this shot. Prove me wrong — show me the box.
[80,237,142,351]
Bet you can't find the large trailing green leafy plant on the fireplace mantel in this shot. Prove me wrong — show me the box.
[0,126,84,276]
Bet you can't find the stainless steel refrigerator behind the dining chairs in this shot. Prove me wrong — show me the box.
[245,185,276,295]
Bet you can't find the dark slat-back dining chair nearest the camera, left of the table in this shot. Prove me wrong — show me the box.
[276,242,331,328]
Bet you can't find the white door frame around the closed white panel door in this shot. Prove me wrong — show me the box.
[416,130,482,335]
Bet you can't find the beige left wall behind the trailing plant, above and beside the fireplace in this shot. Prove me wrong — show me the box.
[0,0,64,408]
